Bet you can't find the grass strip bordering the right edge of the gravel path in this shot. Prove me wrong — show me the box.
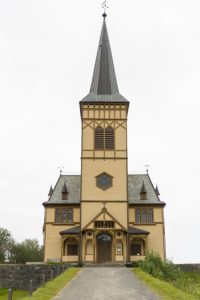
[133,268,197,300]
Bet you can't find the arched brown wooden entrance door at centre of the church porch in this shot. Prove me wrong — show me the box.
[97,233,112,263]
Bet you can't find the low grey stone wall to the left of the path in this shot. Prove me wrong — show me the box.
[0,264,67,290]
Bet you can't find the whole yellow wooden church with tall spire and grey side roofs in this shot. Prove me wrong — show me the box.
[43,12,165,264]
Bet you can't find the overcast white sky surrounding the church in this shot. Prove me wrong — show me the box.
[0,0,200,263]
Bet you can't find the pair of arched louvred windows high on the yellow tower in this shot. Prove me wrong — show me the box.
[95,126,115,150]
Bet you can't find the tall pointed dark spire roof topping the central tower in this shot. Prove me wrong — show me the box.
[81,18,128,103]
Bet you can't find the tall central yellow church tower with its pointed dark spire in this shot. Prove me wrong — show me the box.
[80,14,129,261]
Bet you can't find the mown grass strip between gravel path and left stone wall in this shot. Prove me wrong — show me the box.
[23,268,79,300]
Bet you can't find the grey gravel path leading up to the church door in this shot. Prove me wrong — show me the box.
[53,267,160,300]
